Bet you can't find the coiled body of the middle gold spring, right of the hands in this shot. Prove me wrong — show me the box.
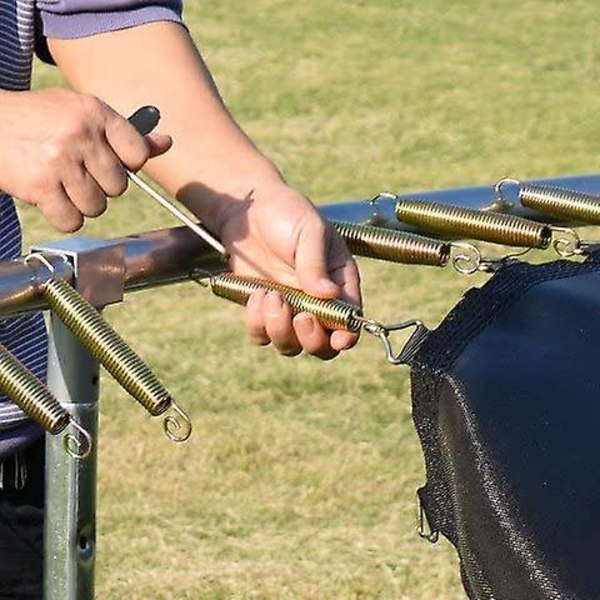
[395,199,552,249]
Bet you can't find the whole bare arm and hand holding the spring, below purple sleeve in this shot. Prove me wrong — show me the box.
[44,22,360,358]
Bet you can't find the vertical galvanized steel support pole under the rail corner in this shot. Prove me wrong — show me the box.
[44,315,99,600]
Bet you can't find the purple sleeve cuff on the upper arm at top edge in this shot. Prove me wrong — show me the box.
[37,0,182,39]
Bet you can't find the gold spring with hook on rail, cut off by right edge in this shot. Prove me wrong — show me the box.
[496,178,600,225]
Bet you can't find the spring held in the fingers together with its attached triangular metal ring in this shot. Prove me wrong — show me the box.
[190,270,427,365]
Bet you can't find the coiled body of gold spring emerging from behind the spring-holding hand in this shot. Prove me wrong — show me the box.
[332,221,451,267]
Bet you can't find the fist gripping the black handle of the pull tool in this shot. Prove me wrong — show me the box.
[0,89,171,233]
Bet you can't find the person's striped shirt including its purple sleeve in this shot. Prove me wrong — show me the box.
[0,0,181,464]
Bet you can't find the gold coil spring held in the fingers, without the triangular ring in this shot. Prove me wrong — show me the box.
[191,271,362,331]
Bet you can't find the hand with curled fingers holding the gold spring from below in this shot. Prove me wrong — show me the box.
[217,183,361,359]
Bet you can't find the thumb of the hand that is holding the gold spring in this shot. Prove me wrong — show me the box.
[296,219,341,298]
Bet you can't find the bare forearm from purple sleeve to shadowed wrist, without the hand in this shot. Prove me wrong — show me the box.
[50,23,282,230]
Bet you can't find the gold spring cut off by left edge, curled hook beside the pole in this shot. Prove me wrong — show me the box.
[0,345,92,459]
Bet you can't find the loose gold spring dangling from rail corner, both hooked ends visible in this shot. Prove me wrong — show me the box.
[25,253,192,442]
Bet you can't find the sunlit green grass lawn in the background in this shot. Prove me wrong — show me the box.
[22,0,600,600]
